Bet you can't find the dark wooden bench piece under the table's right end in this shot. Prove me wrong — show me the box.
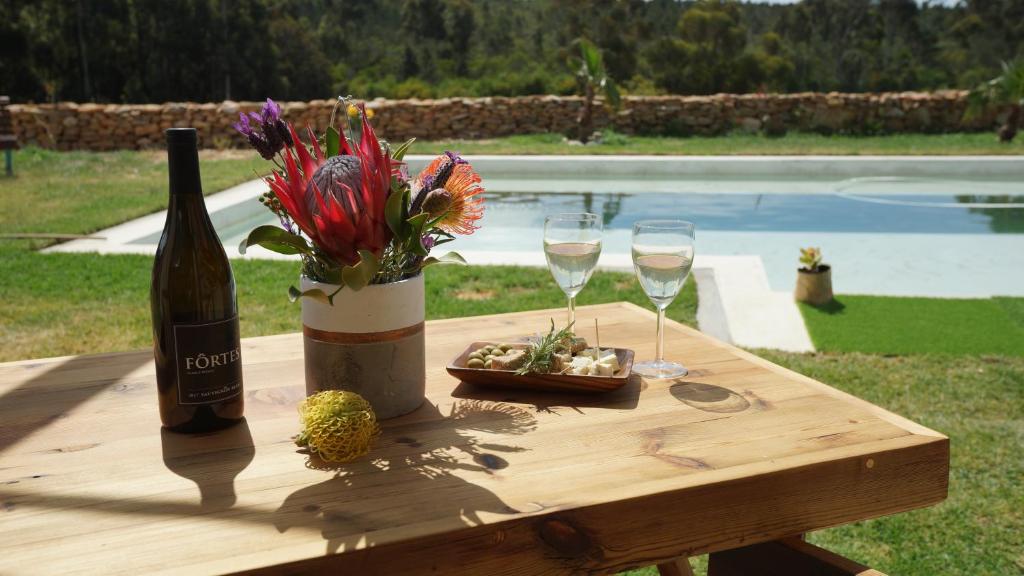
[708,538,885,576]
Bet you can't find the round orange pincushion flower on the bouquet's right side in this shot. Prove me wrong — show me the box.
[413,152,483,235]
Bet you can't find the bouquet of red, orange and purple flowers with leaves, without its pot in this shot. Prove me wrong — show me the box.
[234,98,483,303]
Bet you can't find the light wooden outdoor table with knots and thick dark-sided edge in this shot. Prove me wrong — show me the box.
[0,304,949,574]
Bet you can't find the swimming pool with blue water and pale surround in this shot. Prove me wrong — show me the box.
[59,157,1024,297]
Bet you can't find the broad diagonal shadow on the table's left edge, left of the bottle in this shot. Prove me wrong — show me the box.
[0,352,153,452]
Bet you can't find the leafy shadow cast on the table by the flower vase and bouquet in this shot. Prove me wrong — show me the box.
[273,400,537,553]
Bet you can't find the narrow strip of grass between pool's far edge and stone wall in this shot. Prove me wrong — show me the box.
[412,132,1024,156]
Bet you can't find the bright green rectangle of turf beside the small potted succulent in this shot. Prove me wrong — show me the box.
[801,296,1024,357]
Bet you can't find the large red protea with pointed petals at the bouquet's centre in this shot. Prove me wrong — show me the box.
[267,107,391,265]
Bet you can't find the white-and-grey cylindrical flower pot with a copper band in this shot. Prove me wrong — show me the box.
[301,274,426,420]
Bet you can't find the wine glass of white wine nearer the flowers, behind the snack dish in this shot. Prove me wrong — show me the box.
[544,212,604,326]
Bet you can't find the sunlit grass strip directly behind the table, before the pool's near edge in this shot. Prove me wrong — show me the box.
[0,246,696,362]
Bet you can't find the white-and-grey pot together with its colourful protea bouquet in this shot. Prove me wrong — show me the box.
[236,98,483,419]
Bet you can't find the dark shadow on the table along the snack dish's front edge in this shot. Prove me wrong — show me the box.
[452,374,647,414]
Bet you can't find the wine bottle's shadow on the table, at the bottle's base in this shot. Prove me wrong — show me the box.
[160,419,256,511]
